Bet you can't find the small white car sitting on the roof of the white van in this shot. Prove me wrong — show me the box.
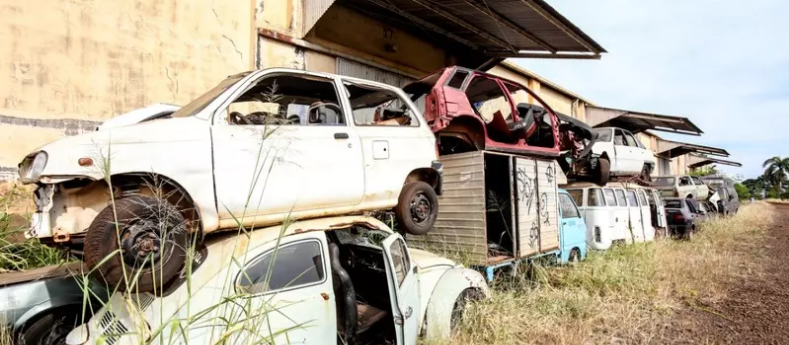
[592,127,655,184]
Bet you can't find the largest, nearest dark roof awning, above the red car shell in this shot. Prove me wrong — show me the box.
[334,0,606,63]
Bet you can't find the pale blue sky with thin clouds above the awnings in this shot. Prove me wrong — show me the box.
[513,0,789,178]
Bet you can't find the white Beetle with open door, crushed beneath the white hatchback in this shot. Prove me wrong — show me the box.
[66,216,489,345]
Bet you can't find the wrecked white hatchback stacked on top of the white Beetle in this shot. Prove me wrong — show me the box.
[19,68,442,291]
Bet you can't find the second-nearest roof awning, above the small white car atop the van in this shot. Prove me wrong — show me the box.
[586,105,704,135]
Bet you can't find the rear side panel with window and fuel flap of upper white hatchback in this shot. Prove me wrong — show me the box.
[343,80,436,206]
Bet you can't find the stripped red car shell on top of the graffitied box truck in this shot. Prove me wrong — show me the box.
[404,66,567,157]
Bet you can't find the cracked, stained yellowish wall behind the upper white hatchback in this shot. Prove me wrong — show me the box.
[0,0,254,170]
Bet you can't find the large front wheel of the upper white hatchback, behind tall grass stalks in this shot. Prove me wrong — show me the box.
[85,196,188,293]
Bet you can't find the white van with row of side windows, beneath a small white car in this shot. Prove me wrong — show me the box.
[564,182,655,250]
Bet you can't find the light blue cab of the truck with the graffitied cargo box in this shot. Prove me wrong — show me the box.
[559,189,586,264]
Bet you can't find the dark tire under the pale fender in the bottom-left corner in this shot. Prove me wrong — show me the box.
[16,306,81,345]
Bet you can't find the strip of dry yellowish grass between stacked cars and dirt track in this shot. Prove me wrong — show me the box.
[440,202,774,344]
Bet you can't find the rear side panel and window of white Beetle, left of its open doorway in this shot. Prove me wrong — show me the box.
[225,231,337,345]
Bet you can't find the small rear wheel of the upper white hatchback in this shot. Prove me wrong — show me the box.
[394,181,438,235]
